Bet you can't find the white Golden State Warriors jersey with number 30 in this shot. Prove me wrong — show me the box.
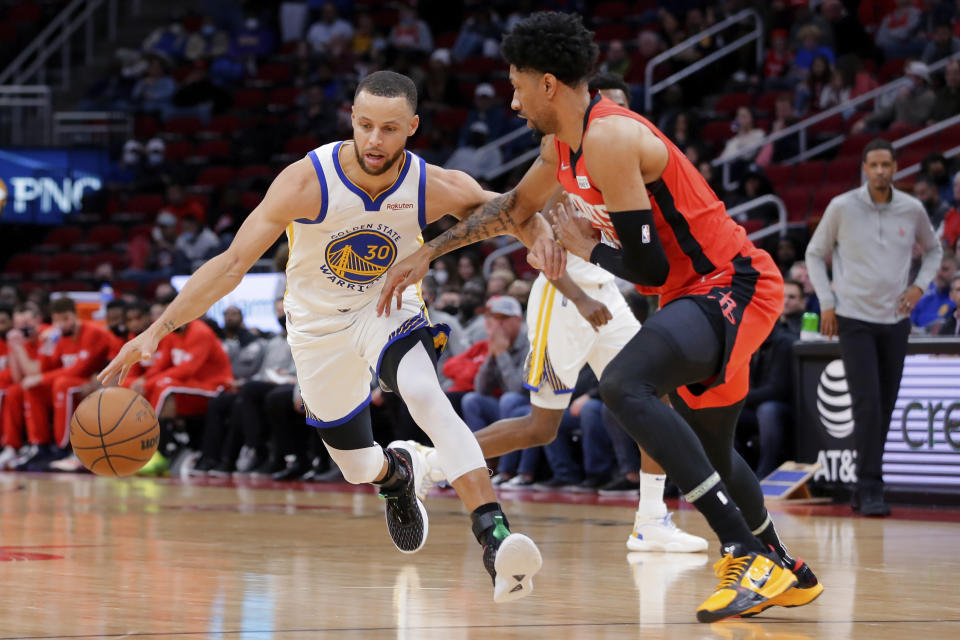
[284,141,427,331]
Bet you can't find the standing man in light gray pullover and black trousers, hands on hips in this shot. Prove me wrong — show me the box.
[806,139,943,516]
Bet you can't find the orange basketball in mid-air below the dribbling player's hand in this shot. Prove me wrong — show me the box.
[70,387,160,476]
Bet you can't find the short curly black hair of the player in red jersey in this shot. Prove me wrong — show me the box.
[500,11,599,86]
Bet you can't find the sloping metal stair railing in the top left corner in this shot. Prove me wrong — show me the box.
[0,0,140,89]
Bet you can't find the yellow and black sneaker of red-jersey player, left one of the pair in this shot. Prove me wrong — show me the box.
[697,543,797,622]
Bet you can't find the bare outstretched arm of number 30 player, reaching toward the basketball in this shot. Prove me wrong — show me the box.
[97,159,320,384]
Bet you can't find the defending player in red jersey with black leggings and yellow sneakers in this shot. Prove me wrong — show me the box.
[378,12,823,622]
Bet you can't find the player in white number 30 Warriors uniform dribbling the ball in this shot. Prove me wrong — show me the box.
[99,71,542,602]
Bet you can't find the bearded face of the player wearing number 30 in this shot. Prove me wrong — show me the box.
[350,91,420,176]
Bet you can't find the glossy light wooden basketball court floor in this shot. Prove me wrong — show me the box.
[0,474,960,640]
